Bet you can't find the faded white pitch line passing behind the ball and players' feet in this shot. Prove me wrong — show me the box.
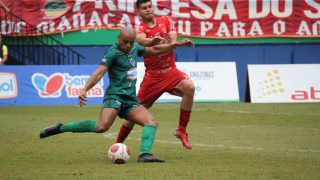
[103,131,320,153]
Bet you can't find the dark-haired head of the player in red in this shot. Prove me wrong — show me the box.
[136,0,154,20]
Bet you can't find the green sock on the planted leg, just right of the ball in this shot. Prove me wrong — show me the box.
[140,125,157,153]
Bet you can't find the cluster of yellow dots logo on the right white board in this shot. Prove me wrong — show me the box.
[258,69,285,98]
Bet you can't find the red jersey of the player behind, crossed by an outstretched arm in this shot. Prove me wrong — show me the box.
[138,16,176,71]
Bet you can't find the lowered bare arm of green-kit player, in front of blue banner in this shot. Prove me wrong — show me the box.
[78,65,108,106]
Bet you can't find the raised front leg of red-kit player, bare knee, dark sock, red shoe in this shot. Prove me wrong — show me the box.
[174,79,195,149]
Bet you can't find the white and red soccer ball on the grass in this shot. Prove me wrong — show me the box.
[108,143,130,164]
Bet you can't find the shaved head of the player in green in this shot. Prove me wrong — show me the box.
[118,27,136,53]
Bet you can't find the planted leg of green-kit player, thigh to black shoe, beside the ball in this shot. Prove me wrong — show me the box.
[127,106,164,162]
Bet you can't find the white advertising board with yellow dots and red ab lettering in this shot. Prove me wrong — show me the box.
[248,64,320,103]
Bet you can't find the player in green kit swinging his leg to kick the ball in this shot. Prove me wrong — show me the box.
[40,28,193,162]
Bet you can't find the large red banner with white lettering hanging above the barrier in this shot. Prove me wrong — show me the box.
[0,0,320,39]
